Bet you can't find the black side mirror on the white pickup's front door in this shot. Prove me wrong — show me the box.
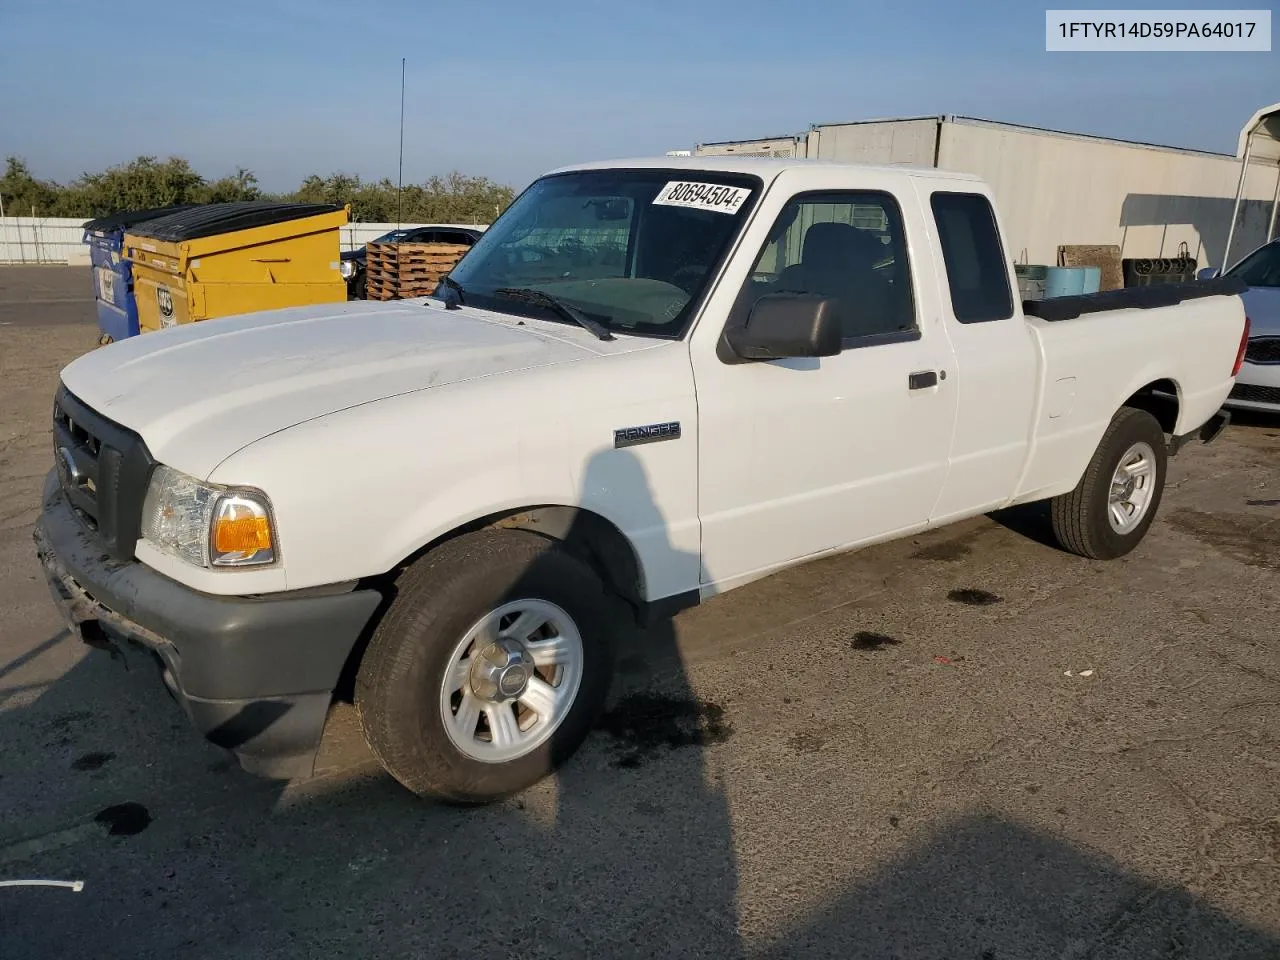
[726,293,845,360]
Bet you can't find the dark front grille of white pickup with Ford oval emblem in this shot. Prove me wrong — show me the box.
[54,387,155,561]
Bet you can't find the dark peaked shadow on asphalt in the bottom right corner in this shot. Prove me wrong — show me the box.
[758,812,1280,960]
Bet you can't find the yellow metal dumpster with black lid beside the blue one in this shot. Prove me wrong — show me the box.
[124,201,348,333]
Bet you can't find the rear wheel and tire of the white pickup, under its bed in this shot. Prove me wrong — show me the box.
[1050,407,1167,559]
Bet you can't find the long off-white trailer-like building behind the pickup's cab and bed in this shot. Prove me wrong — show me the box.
[694,116,1280,266]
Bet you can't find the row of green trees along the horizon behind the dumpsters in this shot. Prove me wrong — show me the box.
[0,156,515,223]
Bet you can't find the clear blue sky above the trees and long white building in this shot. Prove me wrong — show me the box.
[0,0,1280,189]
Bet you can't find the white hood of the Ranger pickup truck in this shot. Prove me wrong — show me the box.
[63,300,640,479]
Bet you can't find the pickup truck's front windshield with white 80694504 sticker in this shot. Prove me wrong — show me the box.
[449,170,760,337]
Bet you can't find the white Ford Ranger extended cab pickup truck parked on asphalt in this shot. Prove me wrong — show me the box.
[36,157,1247,803]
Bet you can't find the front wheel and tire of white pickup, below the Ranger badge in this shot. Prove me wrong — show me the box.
[356,530,613,804]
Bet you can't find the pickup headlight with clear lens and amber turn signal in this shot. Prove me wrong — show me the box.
[141,466,275,567]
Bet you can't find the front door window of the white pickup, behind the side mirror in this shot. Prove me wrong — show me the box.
[745,192,918,347]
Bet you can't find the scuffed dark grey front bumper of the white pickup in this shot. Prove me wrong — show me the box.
[35,474,381,778]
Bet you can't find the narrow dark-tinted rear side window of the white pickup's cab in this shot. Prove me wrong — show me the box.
[929,191,1014,324]
